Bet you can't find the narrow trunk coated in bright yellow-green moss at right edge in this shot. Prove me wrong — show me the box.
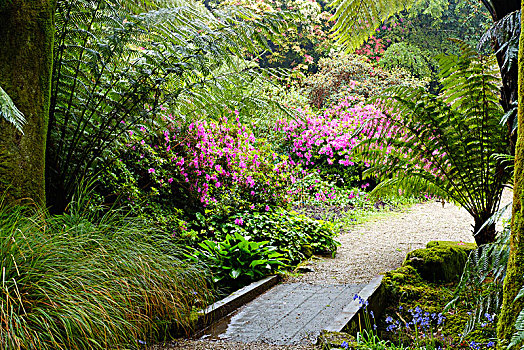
[497,0,524,346]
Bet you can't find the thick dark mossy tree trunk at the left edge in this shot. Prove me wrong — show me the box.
[0,0,54,204]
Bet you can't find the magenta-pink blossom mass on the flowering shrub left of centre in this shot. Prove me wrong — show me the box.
[129,113,299,210]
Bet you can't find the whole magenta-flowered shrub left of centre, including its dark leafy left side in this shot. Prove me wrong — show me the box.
[102,113,298,216]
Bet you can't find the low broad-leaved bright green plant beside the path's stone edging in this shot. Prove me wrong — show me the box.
[187,233,286,287]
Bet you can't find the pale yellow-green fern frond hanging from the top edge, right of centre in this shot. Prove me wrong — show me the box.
[332,0,418,51]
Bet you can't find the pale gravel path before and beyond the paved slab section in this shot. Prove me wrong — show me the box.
[160,193,511,350]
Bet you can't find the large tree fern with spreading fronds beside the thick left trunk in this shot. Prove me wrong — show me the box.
[46,0,287,210]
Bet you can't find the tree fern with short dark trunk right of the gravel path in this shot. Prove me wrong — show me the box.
[359,44,509,244]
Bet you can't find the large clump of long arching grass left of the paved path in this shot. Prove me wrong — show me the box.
[0,201,207,349]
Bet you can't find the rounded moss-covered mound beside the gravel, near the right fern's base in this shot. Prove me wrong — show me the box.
[403,241,476,282]
